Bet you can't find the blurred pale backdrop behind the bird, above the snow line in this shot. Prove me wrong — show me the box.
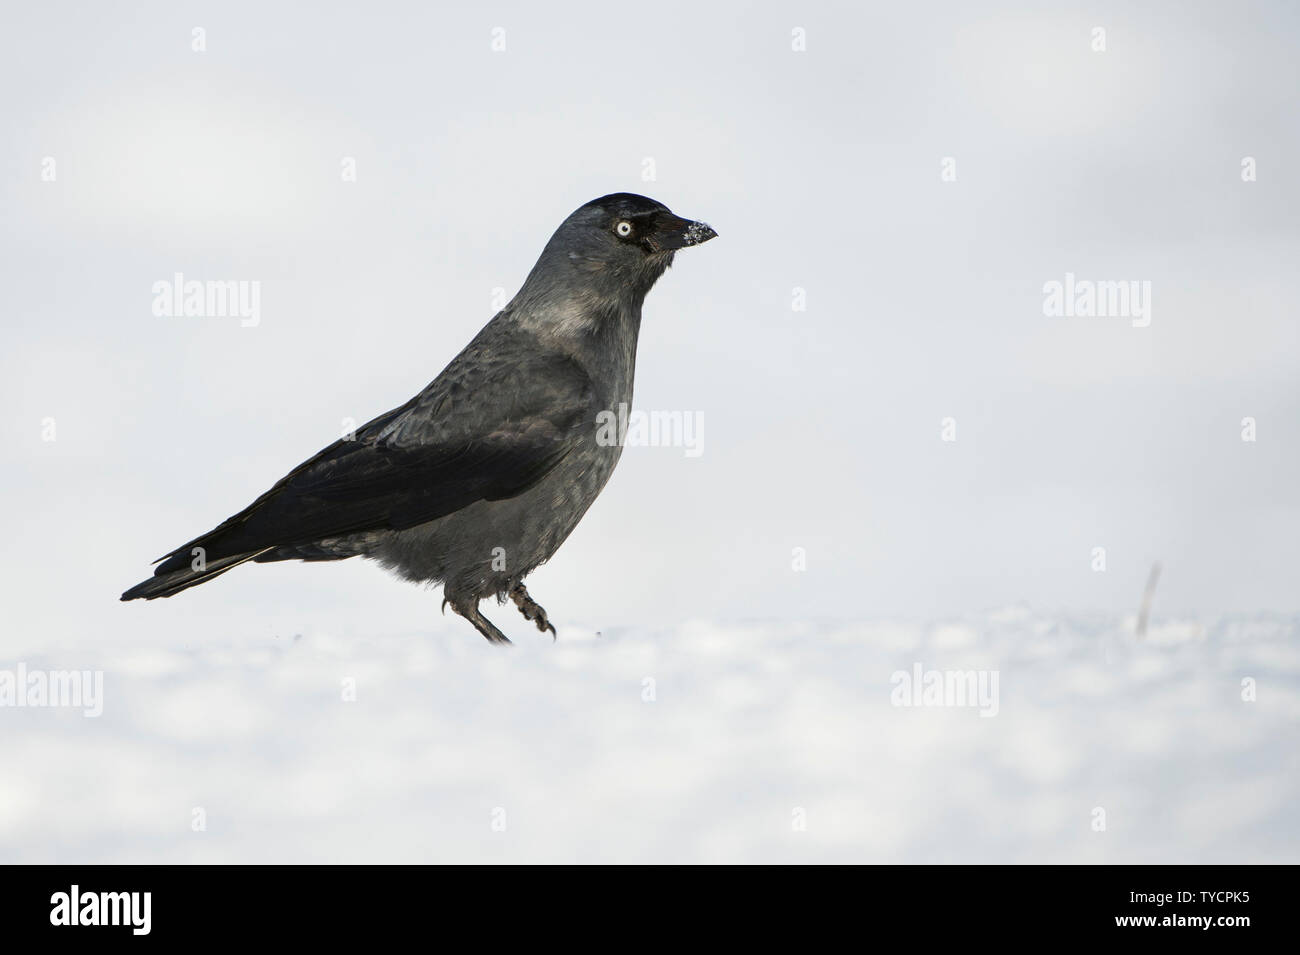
[0,3,1300,646]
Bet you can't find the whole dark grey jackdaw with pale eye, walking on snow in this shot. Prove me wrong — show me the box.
[122,192,716,643]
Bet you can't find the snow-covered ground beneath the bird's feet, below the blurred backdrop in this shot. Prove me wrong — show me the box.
[0,607,1300,863]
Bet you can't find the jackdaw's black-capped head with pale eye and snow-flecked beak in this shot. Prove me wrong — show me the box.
[529,192,718,305]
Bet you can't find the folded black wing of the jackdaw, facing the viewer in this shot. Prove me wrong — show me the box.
[146,350,597,574]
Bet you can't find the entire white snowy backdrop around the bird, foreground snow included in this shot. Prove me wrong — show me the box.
[0,3,1300,861]
